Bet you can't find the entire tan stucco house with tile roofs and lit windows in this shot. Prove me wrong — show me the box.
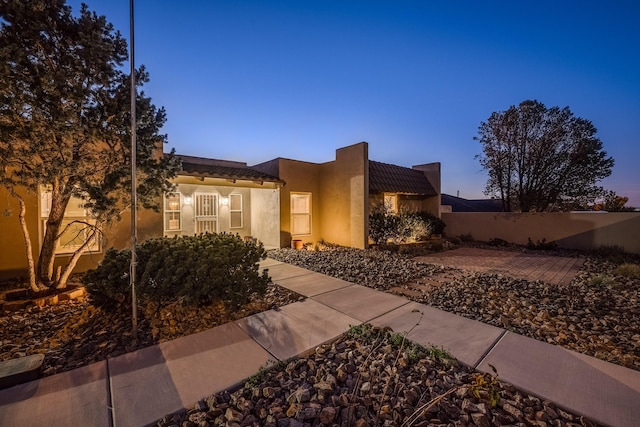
[0,142,441,279]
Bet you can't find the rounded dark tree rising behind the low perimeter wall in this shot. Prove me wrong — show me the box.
[474,101,613,212]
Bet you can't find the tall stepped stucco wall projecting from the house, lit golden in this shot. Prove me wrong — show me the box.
[320,142,369,249]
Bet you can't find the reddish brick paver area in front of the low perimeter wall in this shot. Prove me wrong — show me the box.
[416,248,584,285]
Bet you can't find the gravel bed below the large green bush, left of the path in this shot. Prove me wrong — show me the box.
[0,284,302,376]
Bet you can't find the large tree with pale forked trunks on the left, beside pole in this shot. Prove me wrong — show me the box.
[0,0,178,291]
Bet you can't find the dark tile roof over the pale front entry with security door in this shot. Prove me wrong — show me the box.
[177,154,284,184]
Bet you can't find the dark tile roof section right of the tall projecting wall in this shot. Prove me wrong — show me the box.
[369,160,438,196]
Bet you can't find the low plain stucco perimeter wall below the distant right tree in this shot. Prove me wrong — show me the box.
[442,212,640,253]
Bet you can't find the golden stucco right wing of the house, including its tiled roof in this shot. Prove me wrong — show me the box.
[252,142,440,248]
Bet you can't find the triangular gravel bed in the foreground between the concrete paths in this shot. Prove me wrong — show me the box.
[156,326,597,427]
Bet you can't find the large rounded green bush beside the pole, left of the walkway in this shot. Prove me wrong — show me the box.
[83,233,270,309]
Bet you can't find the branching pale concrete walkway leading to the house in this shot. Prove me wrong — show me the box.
[0,260,640,427]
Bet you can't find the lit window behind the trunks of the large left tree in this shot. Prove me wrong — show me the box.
[40,187,100,254]
